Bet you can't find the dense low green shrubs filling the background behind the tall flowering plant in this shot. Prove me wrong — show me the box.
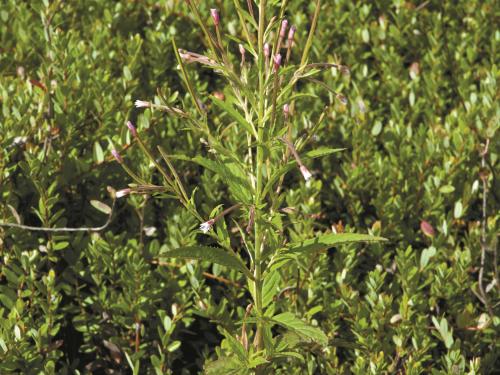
[0,0,500,374]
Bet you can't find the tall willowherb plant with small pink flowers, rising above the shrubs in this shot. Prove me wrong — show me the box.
[113,0,383,373]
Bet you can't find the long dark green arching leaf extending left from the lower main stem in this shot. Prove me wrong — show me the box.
[162,246,253,278]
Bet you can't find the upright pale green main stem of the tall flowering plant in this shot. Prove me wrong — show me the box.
[254,0,266,350]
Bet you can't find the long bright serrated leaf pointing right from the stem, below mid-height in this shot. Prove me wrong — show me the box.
[281,233,387,255]
